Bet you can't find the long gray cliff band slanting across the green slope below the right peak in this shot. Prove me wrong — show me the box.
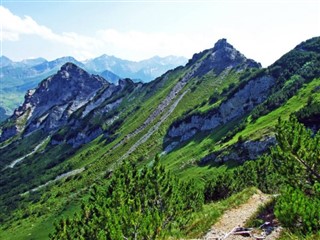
[167,76,275,142]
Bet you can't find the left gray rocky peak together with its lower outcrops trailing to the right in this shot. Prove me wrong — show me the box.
[0,63,140,146]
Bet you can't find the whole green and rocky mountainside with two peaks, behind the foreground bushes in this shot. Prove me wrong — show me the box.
[0,37,320,239]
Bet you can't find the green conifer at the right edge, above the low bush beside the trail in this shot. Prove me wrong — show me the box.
[272,117,320,188]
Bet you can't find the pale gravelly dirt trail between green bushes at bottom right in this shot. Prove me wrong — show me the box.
[202,192,278,240]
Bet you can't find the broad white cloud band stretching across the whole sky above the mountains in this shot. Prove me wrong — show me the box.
[0,6,319,66]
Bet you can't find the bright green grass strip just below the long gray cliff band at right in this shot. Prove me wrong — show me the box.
[163,78,320,180]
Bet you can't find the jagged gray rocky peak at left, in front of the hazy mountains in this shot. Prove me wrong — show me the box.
[0,63,109,141]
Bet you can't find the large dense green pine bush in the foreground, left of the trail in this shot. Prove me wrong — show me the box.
[51,158,203,239]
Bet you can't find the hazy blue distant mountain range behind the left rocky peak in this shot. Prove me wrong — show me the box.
[0,55,187,122]
